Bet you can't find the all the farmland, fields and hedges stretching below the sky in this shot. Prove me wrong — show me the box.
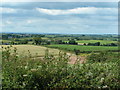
[0,34,120,90]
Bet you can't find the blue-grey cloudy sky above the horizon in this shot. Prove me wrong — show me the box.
[0,2,118,34]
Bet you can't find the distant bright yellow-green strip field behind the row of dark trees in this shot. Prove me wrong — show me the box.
[66,40,117,44]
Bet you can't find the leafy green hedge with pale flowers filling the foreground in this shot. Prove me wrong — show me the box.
[2,46,120,89]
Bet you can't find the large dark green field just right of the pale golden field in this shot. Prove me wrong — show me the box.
[47,45,118,51]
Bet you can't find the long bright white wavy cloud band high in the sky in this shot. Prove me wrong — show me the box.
[36,7,117,15]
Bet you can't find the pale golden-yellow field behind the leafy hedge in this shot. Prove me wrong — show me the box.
[2,45,59,56]
